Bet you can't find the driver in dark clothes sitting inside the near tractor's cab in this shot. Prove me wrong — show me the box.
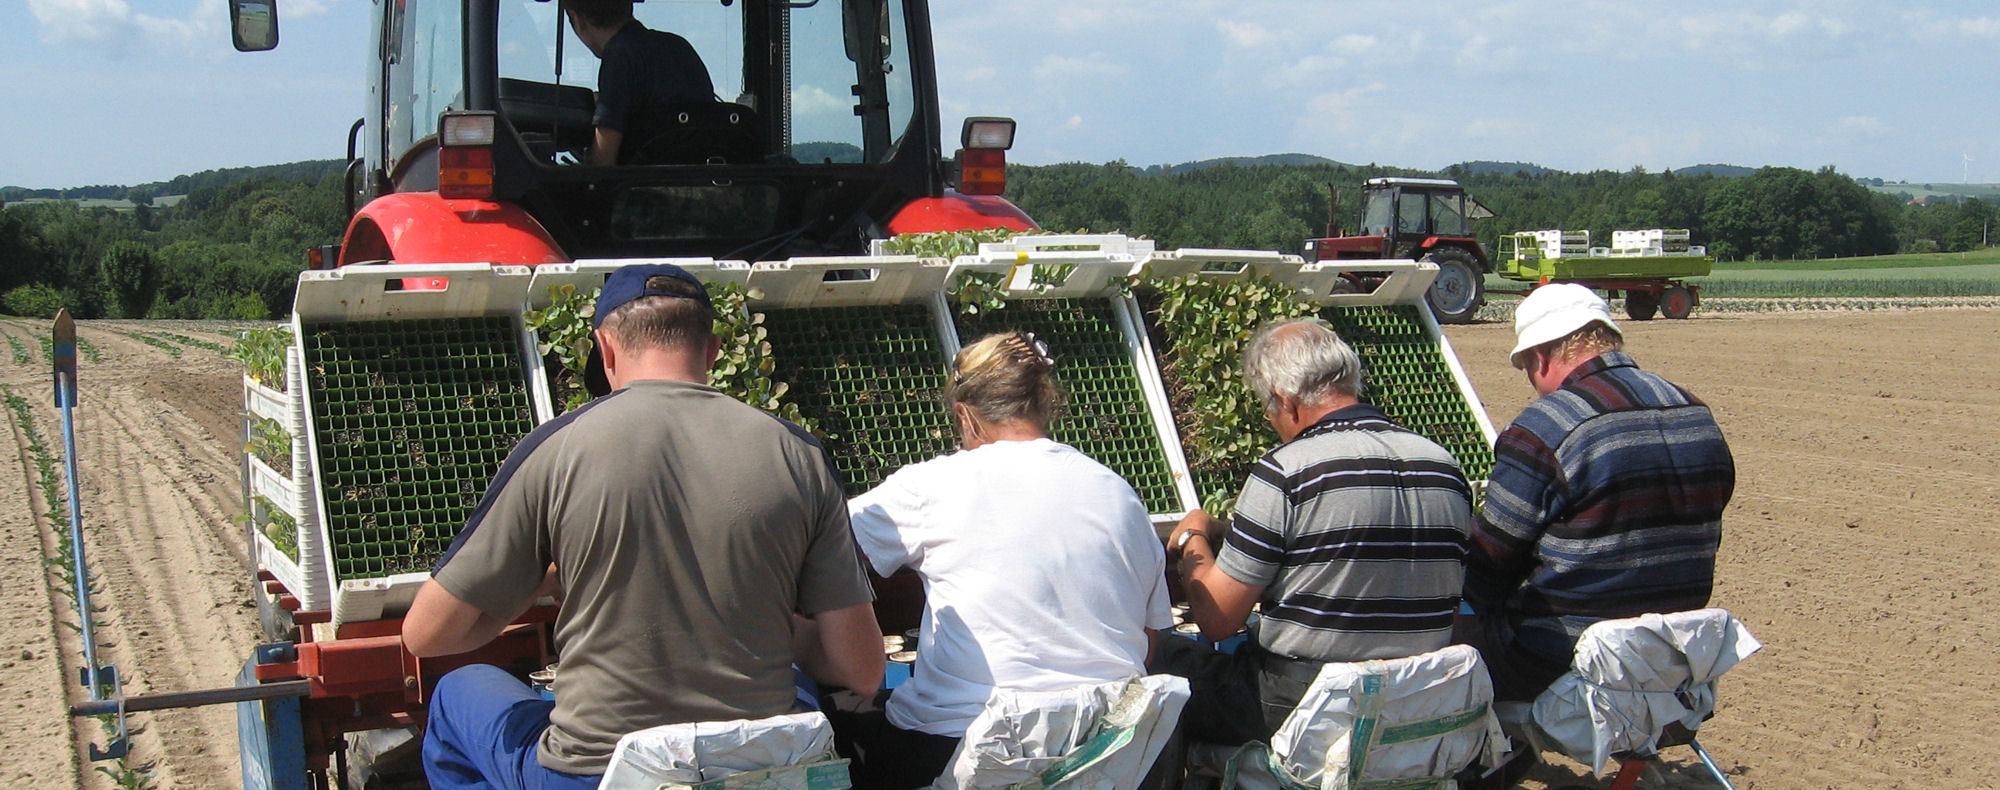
[562,0,716,164]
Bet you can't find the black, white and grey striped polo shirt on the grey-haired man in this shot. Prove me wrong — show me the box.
[1216,404,1472,662]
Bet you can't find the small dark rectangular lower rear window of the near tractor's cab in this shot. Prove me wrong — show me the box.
[612,186,778,242]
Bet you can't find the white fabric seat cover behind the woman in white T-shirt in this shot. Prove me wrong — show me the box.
[932,674,1188,790]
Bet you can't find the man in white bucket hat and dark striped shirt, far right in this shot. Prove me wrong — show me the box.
[1458,284,1736,700]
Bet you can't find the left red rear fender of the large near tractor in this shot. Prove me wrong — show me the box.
[340,192,570,266]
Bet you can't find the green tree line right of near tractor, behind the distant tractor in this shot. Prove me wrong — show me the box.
[1008,162,1996,260]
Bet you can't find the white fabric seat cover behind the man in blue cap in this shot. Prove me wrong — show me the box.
[598,712,850,790]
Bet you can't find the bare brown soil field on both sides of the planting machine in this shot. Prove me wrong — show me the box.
[0,308,2000,788]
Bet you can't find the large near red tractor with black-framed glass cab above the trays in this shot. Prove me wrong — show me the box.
[234,0,1032,264]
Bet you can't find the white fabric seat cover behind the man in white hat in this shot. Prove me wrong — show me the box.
[1534,608,1762,772]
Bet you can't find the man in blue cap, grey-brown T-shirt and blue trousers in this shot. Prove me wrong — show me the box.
[402,264,884,788]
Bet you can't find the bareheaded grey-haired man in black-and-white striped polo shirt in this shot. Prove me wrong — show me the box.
[1154,318,1472,744]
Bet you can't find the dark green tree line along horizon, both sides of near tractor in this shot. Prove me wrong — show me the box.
[0,160,1996,318]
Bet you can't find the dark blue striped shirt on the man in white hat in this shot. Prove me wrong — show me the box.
[1466,352,1736,636]
